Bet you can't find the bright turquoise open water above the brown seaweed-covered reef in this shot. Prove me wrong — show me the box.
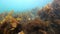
[0,0,52,12]
